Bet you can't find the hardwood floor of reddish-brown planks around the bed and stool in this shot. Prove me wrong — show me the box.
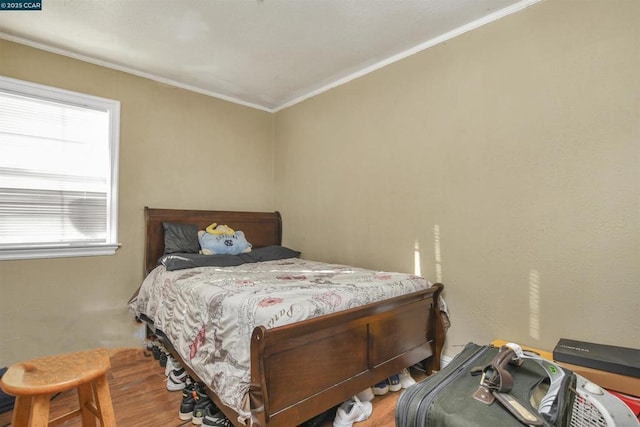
[0,348,419,427]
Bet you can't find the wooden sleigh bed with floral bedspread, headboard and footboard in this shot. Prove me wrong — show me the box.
[129,207,446,427]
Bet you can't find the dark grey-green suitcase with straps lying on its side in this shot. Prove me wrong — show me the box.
[395,343,576,427]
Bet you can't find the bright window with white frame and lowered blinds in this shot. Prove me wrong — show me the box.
[0,76,120,260]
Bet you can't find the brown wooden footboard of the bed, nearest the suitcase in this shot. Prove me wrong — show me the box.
[249,284,444,426]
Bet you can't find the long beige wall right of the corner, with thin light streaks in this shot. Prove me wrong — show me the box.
[275,0,640,355]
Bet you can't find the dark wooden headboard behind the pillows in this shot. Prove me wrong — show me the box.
[144,206,282,276]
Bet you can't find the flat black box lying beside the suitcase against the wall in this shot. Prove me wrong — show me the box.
[553,338,640,378]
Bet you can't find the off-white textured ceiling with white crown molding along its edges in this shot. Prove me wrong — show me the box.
[0,0,538,111]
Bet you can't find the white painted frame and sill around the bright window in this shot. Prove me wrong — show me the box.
[0,76,120,260]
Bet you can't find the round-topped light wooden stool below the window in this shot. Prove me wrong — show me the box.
[0,349,116,427]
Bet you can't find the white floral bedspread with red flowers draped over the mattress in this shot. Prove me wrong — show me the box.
[129,258,446,420]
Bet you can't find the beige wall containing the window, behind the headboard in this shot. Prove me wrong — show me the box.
[0,40,274,366]
